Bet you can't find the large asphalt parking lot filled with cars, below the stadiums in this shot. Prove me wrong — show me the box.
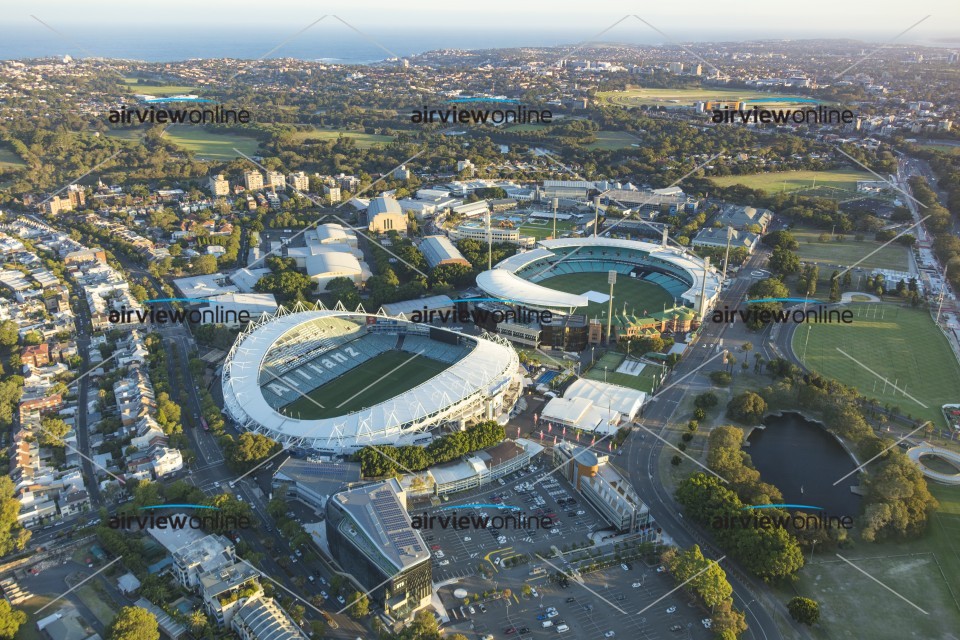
[428,462,712,639]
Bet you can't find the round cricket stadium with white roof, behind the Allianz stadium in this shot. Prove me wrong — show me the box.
[477,237,721,317]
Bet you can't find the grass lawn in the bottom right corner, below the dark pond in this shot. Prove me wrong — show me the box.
[784,484,960,639]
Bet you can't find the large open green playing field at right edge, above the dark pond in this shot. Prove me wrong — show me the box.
[793,303,960,427]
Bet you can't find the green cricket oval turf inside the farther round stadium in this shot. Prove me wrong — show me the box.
[538,271,674,318]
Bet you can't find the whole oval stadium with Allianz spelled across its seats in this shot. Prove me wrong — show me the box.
[221,305,522,453]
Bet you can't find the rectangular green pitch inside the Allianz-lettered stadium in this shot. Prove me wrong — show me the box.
[281,351,450,420]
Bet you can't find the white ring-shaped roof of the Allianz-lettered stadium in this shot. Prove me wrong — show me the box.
[222,302,520,451]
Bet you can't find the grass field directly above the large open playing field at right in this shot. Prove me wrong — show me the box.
[790,227,910,272]
